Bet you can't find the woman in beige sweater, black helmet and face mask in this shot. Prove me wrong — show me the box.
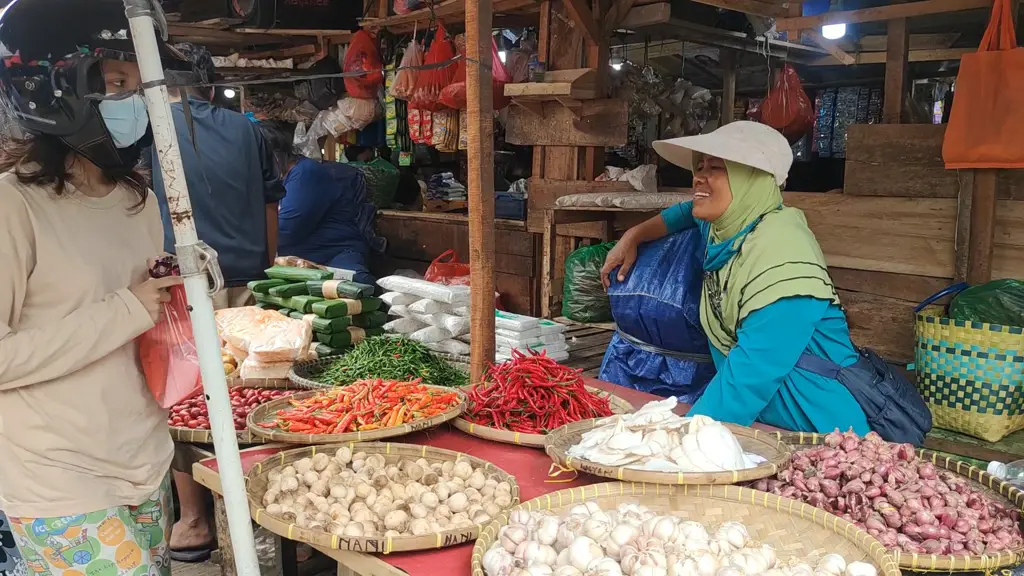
[0,0,178,576]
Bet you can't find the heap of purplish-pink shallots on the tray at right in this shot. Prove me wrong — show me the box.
[754,430,1024,554]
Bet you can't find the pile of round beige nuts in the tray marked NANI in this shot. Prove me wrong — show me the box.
[263,447,513,537]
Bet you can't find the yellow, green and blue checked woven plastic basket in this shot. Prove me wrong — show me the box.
[914,287,1024,442]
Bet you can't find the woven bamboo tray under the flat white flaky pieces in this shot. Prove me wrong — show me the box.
[544,418,790,484]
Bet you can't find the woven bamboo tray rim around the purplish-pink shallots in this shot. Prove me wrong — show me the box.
[775,433,1024,573]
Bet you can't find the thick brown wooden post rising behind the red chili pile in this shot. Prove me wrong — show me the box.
[466,0,495,382]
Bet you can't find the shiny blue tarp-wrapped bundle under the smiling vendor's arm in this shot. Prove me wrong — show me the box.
[600,229,715,403]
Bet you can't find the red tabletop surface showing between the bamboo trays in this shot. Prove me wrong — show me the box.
[200,378,774,576]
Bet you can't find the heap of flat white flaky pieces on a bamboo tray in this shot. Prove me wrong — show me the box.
[566,397,764,472]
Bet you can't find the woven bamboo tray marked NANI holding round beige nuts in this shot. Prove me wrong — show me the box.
[246,442,519,554]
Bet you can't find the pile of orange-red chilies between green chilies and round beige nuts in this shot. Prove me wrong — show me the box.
[260,378,459,434]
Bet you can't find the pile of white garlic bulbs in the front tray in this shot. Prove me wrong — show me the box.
[482,502,878,576]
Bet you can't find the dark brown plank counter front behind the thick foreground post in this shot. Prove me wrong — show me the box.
[377,214,539,316]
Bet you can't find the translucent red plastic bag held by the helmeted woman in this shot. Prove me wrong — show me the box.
[138,258,203,409]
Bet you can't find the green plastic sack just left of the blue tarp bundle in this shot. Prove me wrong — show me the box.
[562,242,615,322]
